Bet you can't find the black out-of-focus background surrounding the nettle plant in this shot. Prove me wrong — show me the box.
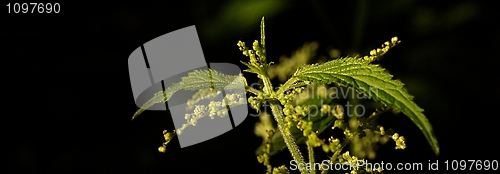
[0,0,500,173]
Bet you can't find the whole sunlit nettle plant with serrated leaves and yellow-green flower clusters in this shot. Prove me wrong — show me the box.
[132,17,439,174]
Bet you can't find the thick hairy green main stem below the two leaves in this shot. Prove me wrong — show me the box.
[269,100,308,174]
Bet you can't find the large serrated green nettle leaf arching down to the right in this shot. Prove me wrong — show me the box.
[294,57,439,155]
